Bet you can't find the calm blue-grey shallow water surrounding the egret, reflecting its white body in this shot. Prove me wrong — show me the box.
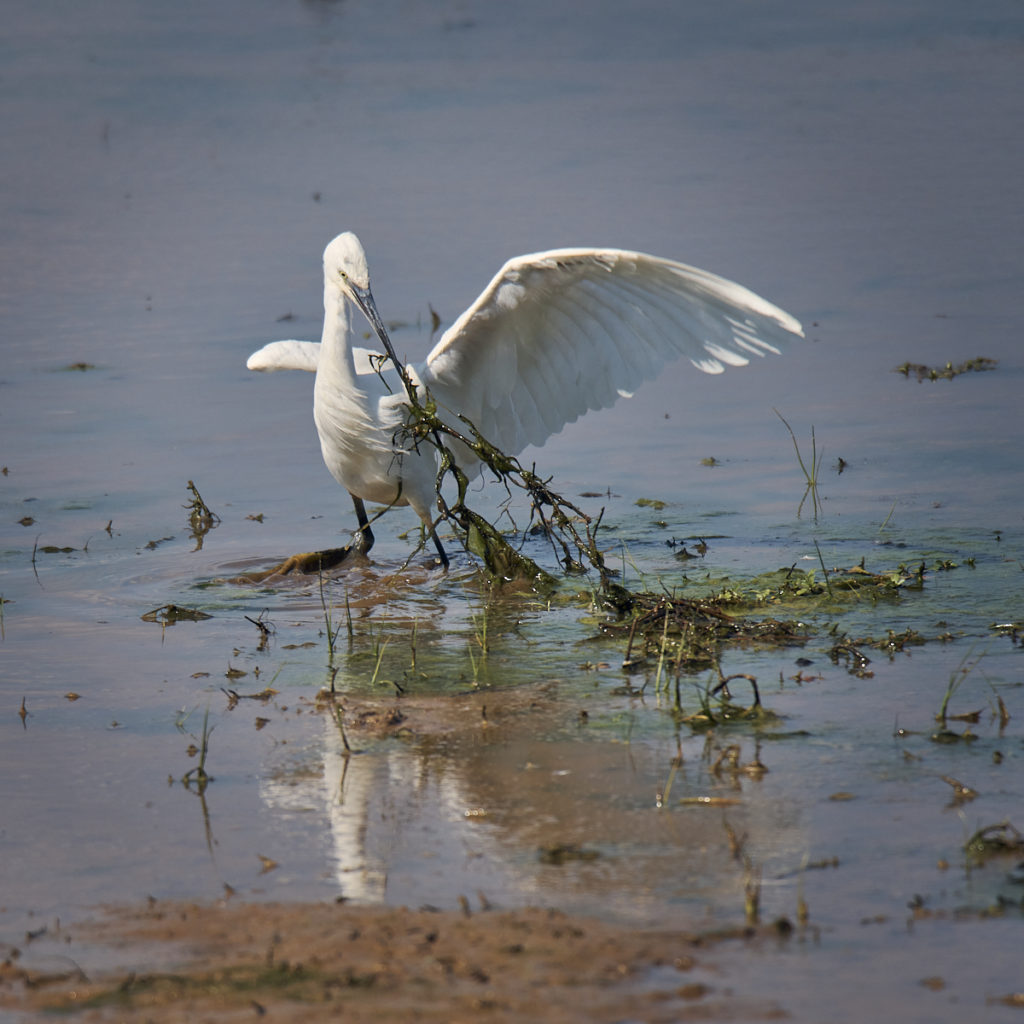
[0,0,1024,1020]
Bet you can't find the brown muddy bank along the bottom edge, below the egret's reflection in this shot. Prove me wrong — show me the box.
[0,901,787,1024]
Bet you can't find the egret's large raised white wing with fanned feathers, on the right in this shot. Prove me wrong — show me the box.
[419,249,803,455]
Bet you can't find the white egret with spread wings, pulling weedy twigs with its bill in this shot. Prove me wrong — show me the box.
[247,232,803,565]
